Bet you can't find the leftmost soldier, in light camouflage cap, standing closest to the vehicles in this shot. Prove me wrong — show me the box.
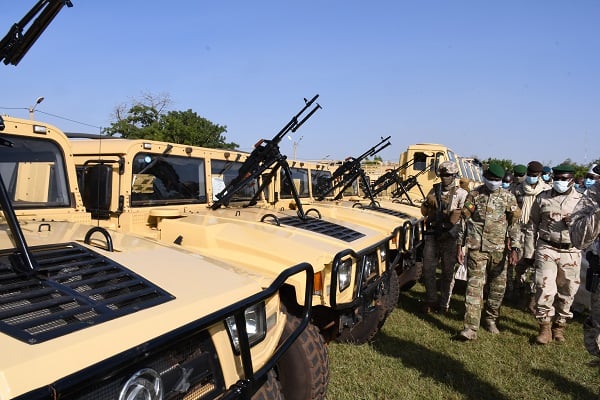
[421,161,467,313]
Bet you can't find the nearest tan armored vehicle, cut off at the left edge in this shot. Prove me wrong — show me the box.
[0,117,328,399]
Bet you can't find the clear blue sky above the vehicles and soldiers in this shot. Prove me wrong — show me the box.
[0,0,600,165]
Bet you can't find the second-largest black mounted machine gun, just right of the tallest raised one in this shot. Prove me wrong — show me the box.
[317,136,391,201]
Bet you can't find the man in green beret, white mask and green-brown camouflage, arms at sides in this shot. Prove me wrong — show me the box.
[457,163,520,340]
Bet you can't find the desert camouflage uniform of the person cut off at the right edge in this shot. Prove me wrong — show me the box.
[569,182,600,357]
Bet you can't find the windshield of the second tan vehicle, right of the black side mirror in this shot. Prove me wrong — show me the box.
[131,153,206,206]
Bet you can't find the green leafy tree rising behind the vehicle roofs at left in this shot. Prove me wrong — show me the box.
[104,94,239,149]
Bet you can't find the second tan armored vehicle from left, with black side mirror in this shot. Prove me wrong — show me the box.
[71,96,398,343]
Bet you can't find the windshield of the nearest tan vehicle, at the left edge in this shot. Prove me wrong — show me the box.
[0,135,71,209]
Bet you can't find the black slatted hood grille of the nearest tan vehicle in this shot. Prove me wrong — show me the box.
[0,243,174,344]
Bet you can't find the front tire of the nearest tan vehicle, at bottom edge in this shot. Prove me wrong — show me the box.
[276,314,329,400]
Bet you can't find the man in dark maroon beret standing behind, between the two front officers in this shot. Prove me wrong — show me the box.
[509,161,550,314]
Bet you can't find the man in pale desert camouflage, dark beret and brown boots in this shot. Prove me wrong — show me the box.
[523,164,581,344]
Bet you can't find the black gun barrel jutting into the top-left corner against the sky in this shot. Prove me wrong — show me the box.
[0,0,73,65]
